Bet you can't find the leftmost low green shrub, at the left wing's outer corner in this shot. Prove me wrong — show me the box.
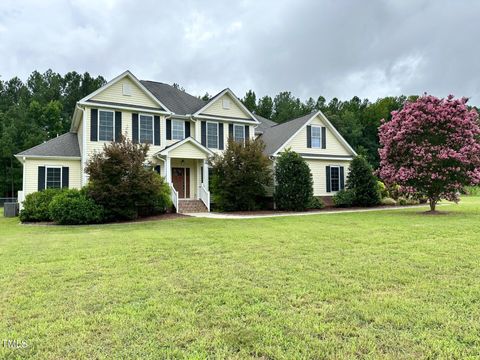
[20,189,64,222]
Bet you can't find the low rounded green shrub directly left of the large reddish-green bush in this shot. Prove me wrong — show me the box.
[48,189,104,225]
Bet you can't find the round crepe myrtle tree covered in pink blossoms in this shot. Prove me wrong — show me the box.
[379,94,480,212]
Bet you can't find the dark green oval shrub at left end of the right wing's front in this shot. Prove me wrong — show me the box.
[274,149,313,211]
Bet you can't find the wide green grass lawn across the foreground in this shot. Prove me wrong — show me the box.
[0,197,480,359]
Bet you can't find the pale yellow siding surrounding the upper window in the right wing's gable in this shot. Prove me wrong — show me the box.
[285,116,352,155]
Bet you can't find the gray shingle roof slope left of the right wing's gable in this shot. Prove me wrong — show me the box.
[262,112,316,155]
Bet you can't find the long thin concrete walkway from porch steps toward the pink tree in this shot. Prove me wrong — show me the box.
[184,204,438,219]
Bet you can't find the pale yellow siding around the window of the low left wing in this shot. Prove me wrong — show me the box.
[23,158,81,195]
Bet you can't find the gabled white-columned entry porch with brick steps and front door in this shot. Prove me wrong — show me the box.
[155,137,212,212]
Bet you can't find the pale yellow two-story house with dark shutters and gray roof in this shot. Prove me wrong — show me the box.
[15,71,355,211]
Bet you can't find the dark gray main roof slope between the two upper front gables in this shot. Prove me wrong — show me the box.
[140,80,206,115]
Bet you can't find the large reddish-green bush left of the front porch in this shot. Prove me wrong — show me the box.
[85,137,171,221]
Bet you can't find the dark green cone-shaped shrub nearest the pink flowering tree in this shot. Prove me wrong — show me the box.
[346,155,380,206]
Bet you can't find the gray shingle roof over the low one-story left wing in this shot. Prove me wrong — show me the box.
[17,132,80,157]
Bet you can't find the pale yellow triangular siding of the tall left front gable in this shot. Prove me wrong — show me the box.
[91,77,160,108]
